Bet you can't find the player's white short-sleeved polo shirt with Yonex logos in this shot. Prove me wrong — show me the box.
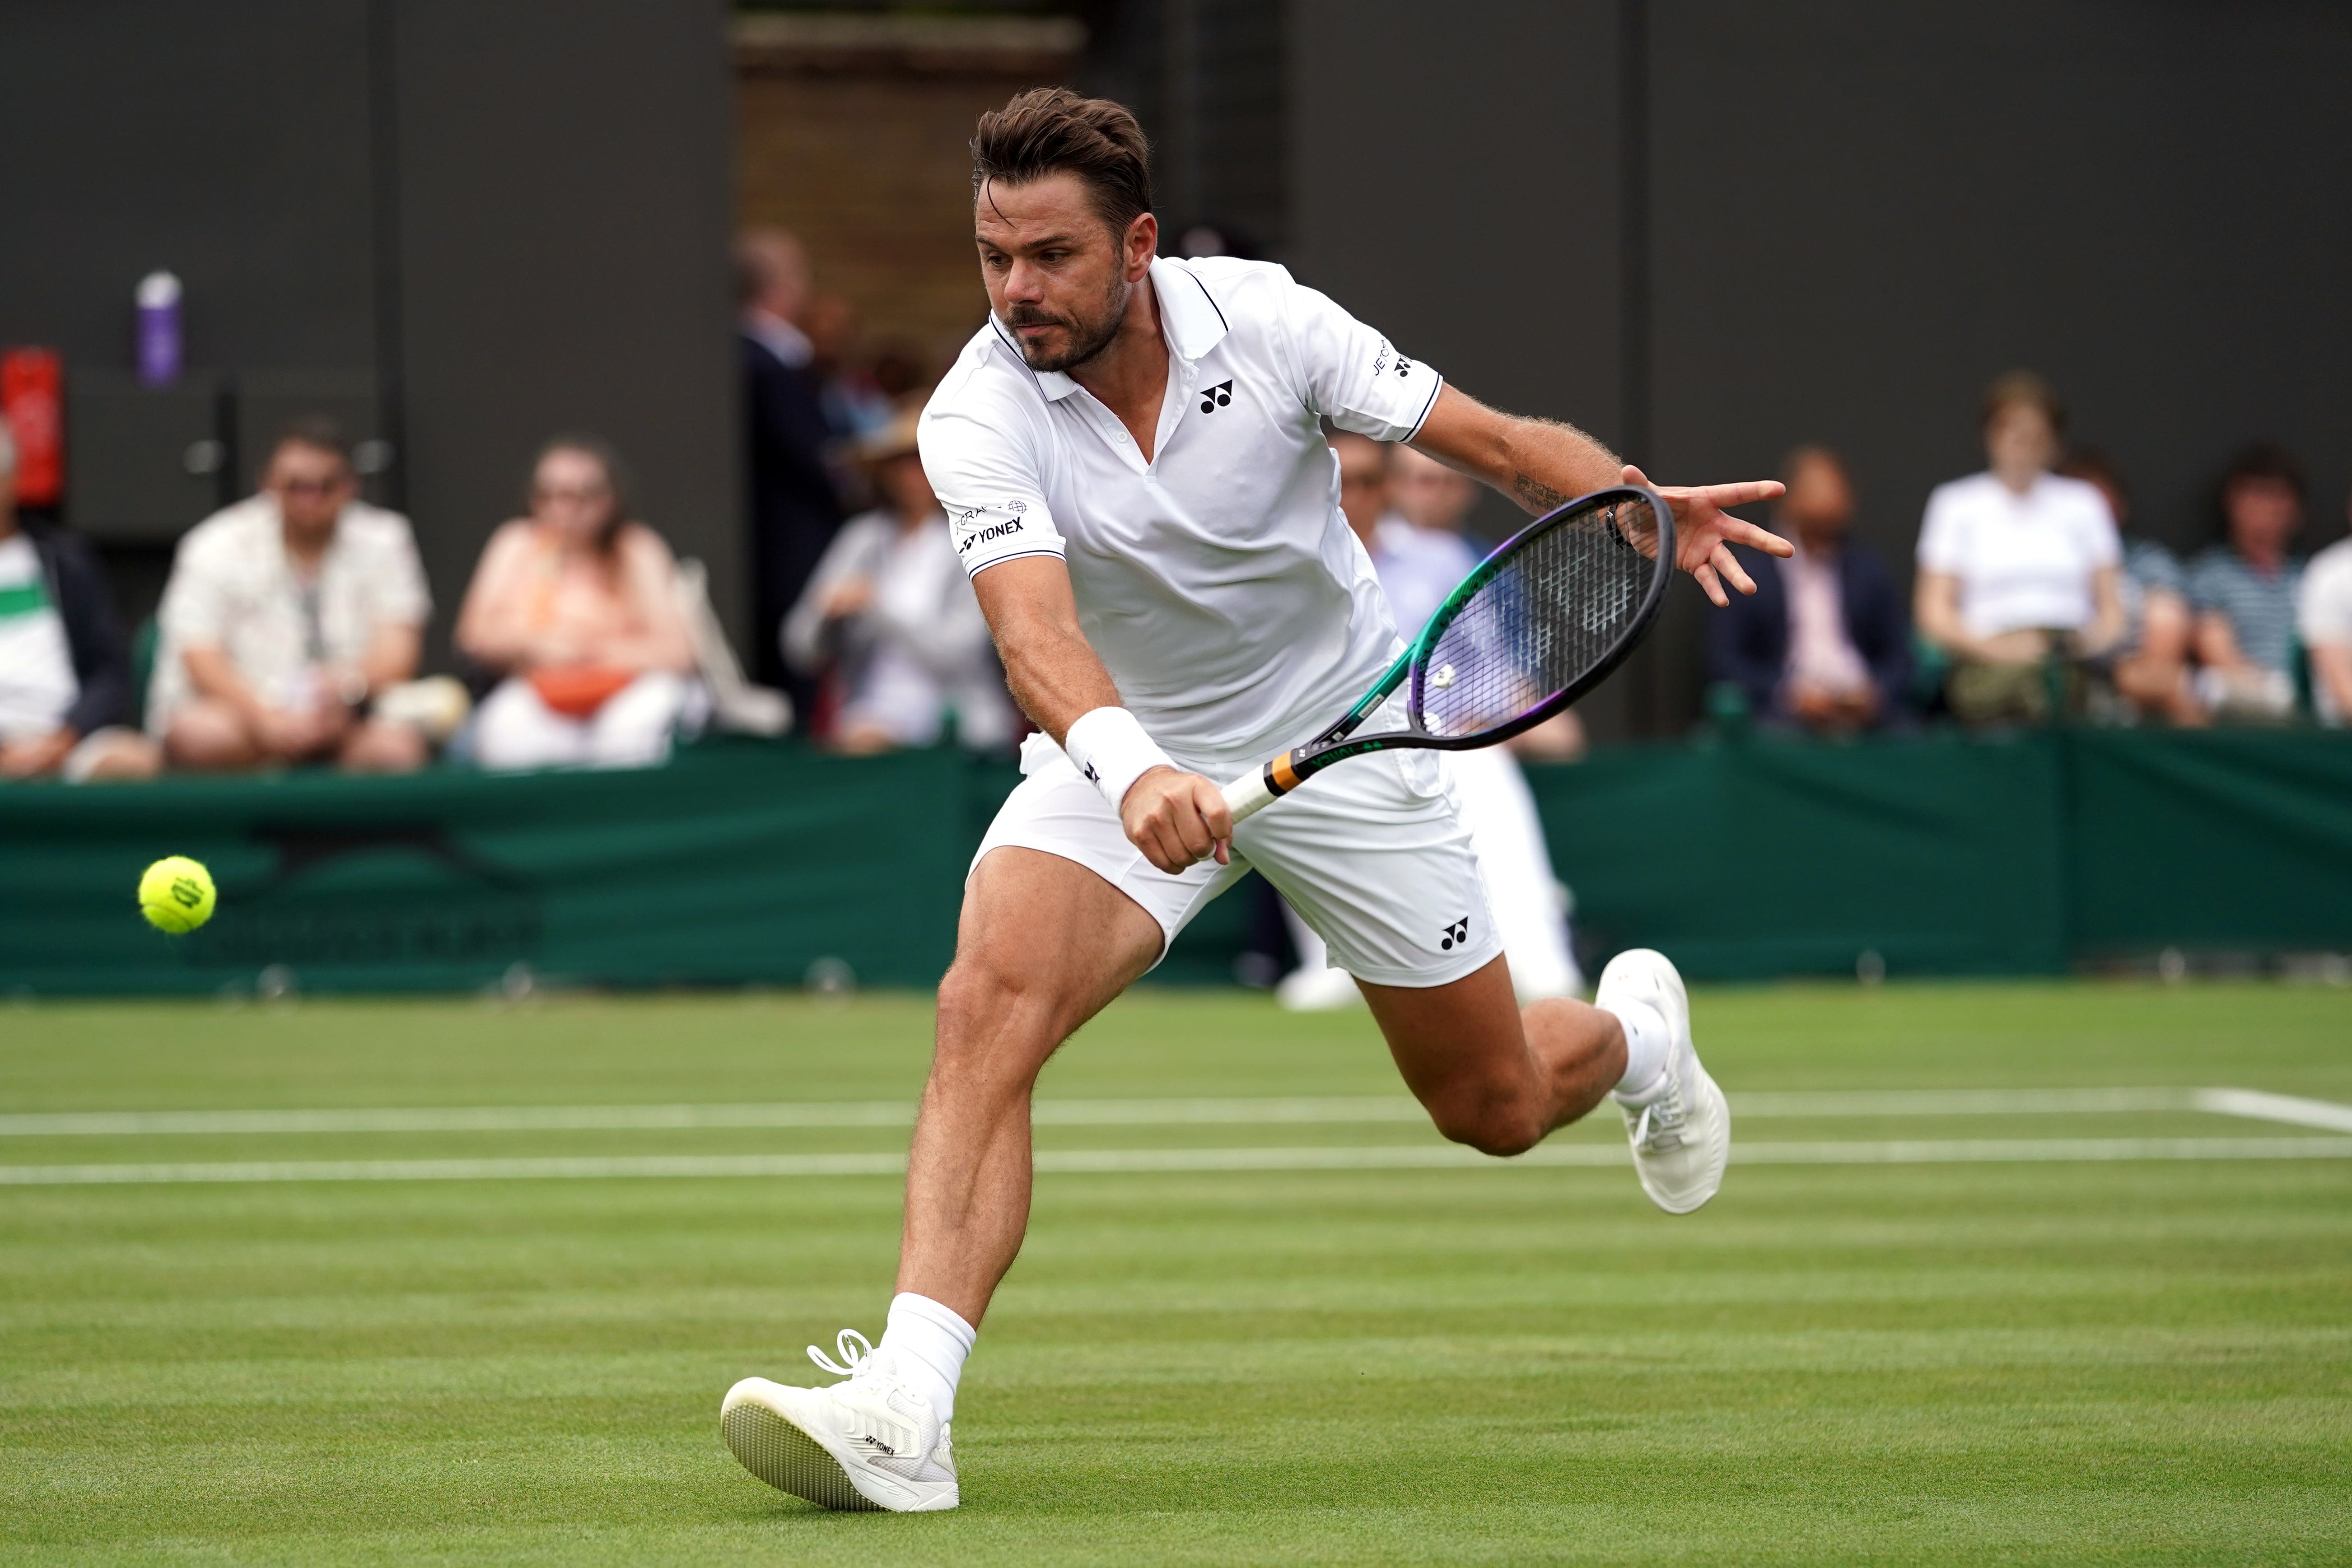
[922,256,1439,769]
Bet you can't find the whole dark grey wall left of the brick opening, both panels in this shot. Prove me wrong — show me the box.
[0,0,743,646]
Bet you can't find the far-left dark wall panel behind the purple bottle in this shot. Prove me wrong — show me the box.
[0,0,376,369]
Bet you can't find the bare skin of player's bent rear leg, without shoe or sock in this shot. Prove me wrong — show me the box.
[1362,959,1625,1154]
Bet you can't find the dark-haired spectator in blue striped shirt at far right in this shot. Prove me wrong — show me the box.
[2190,442,2310,719]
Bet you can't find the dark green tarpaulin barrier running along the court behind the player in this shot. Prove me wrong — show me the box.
[0,731,2352,994]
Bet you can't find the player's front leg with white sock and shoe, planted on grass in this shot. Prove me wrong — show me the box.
[720,846,1162,1512]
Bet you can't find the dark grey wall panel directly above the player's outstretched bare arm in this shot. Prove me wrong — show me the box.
[1284,0,1649,733]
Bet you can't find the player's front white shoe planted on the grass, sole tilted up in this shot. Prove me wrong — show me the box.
[720,1328,957,1514]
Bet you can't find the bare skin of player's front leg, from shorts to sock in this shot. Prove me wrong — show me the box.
[898,849,1162,1324]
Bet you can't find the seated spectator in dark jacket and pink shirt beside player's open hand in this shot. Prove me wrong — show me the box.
[1708,447,1910,731]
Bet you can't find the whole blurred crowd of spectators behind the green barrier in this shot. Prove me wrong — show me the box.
[0,250,2352,799]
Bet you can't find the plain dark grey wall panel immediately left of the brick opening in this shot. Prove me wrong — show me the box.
[393,0,748,646]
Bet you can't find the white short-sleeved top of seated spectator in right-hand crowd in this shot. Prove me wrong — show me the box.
[1919,472,2124,637]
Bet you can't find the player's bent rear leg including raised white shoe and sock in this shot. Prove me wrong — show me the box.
[1364,947,1731,1213]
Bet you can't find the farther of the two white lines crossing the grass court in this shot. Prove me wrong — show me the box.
[0,1088,2352,1138]
